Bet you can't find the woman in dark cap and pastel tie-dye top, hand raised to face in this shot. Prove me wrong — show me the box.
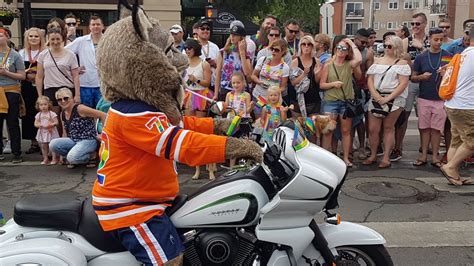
[215,24,252,101]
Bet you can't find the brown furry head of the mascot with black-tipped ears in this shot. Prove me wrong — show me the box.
[97,0,188,125]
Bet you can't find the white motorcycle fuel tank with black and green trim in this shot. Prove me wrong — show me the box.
[171,167,273,228]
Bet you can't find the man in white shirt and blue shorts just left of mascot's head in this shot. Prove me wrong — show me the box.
[66,16,104,109]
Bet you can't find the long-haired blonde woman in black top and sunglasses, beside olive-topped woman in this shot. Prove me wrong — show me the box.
[290,35,321,121]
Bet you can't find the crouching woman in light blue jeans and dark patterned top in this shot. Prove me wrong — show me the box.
[49,88,106,168]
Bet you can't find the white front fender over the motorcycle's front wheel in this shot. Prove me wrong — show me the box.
[318,222,386,249]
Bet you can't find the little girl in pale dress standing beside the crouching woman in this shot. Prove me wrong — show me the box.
[35,96,59,165]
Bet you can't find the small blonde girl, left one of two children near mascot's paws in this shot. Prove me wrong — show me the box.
[224,71,253,118]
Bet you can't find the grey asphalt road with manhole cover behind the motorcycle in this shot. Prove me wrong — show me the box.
[0,113,474,265]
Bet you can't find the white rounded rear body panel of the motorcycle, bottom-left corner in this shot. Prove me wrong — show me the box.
[0,238,87,266]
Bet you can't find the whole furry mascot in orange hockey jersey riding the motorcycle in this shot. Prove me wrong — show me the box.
[92,0,263,265]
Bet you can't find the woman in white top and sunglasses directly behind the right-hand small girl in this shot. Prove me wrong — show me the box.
[251,39,290,117]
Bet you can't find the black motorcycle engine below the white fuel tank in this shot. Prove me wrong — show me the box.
[184,230,256,266]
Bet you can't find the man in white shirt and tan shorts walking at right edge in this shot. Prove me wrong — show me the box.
[440,25,474,186]
